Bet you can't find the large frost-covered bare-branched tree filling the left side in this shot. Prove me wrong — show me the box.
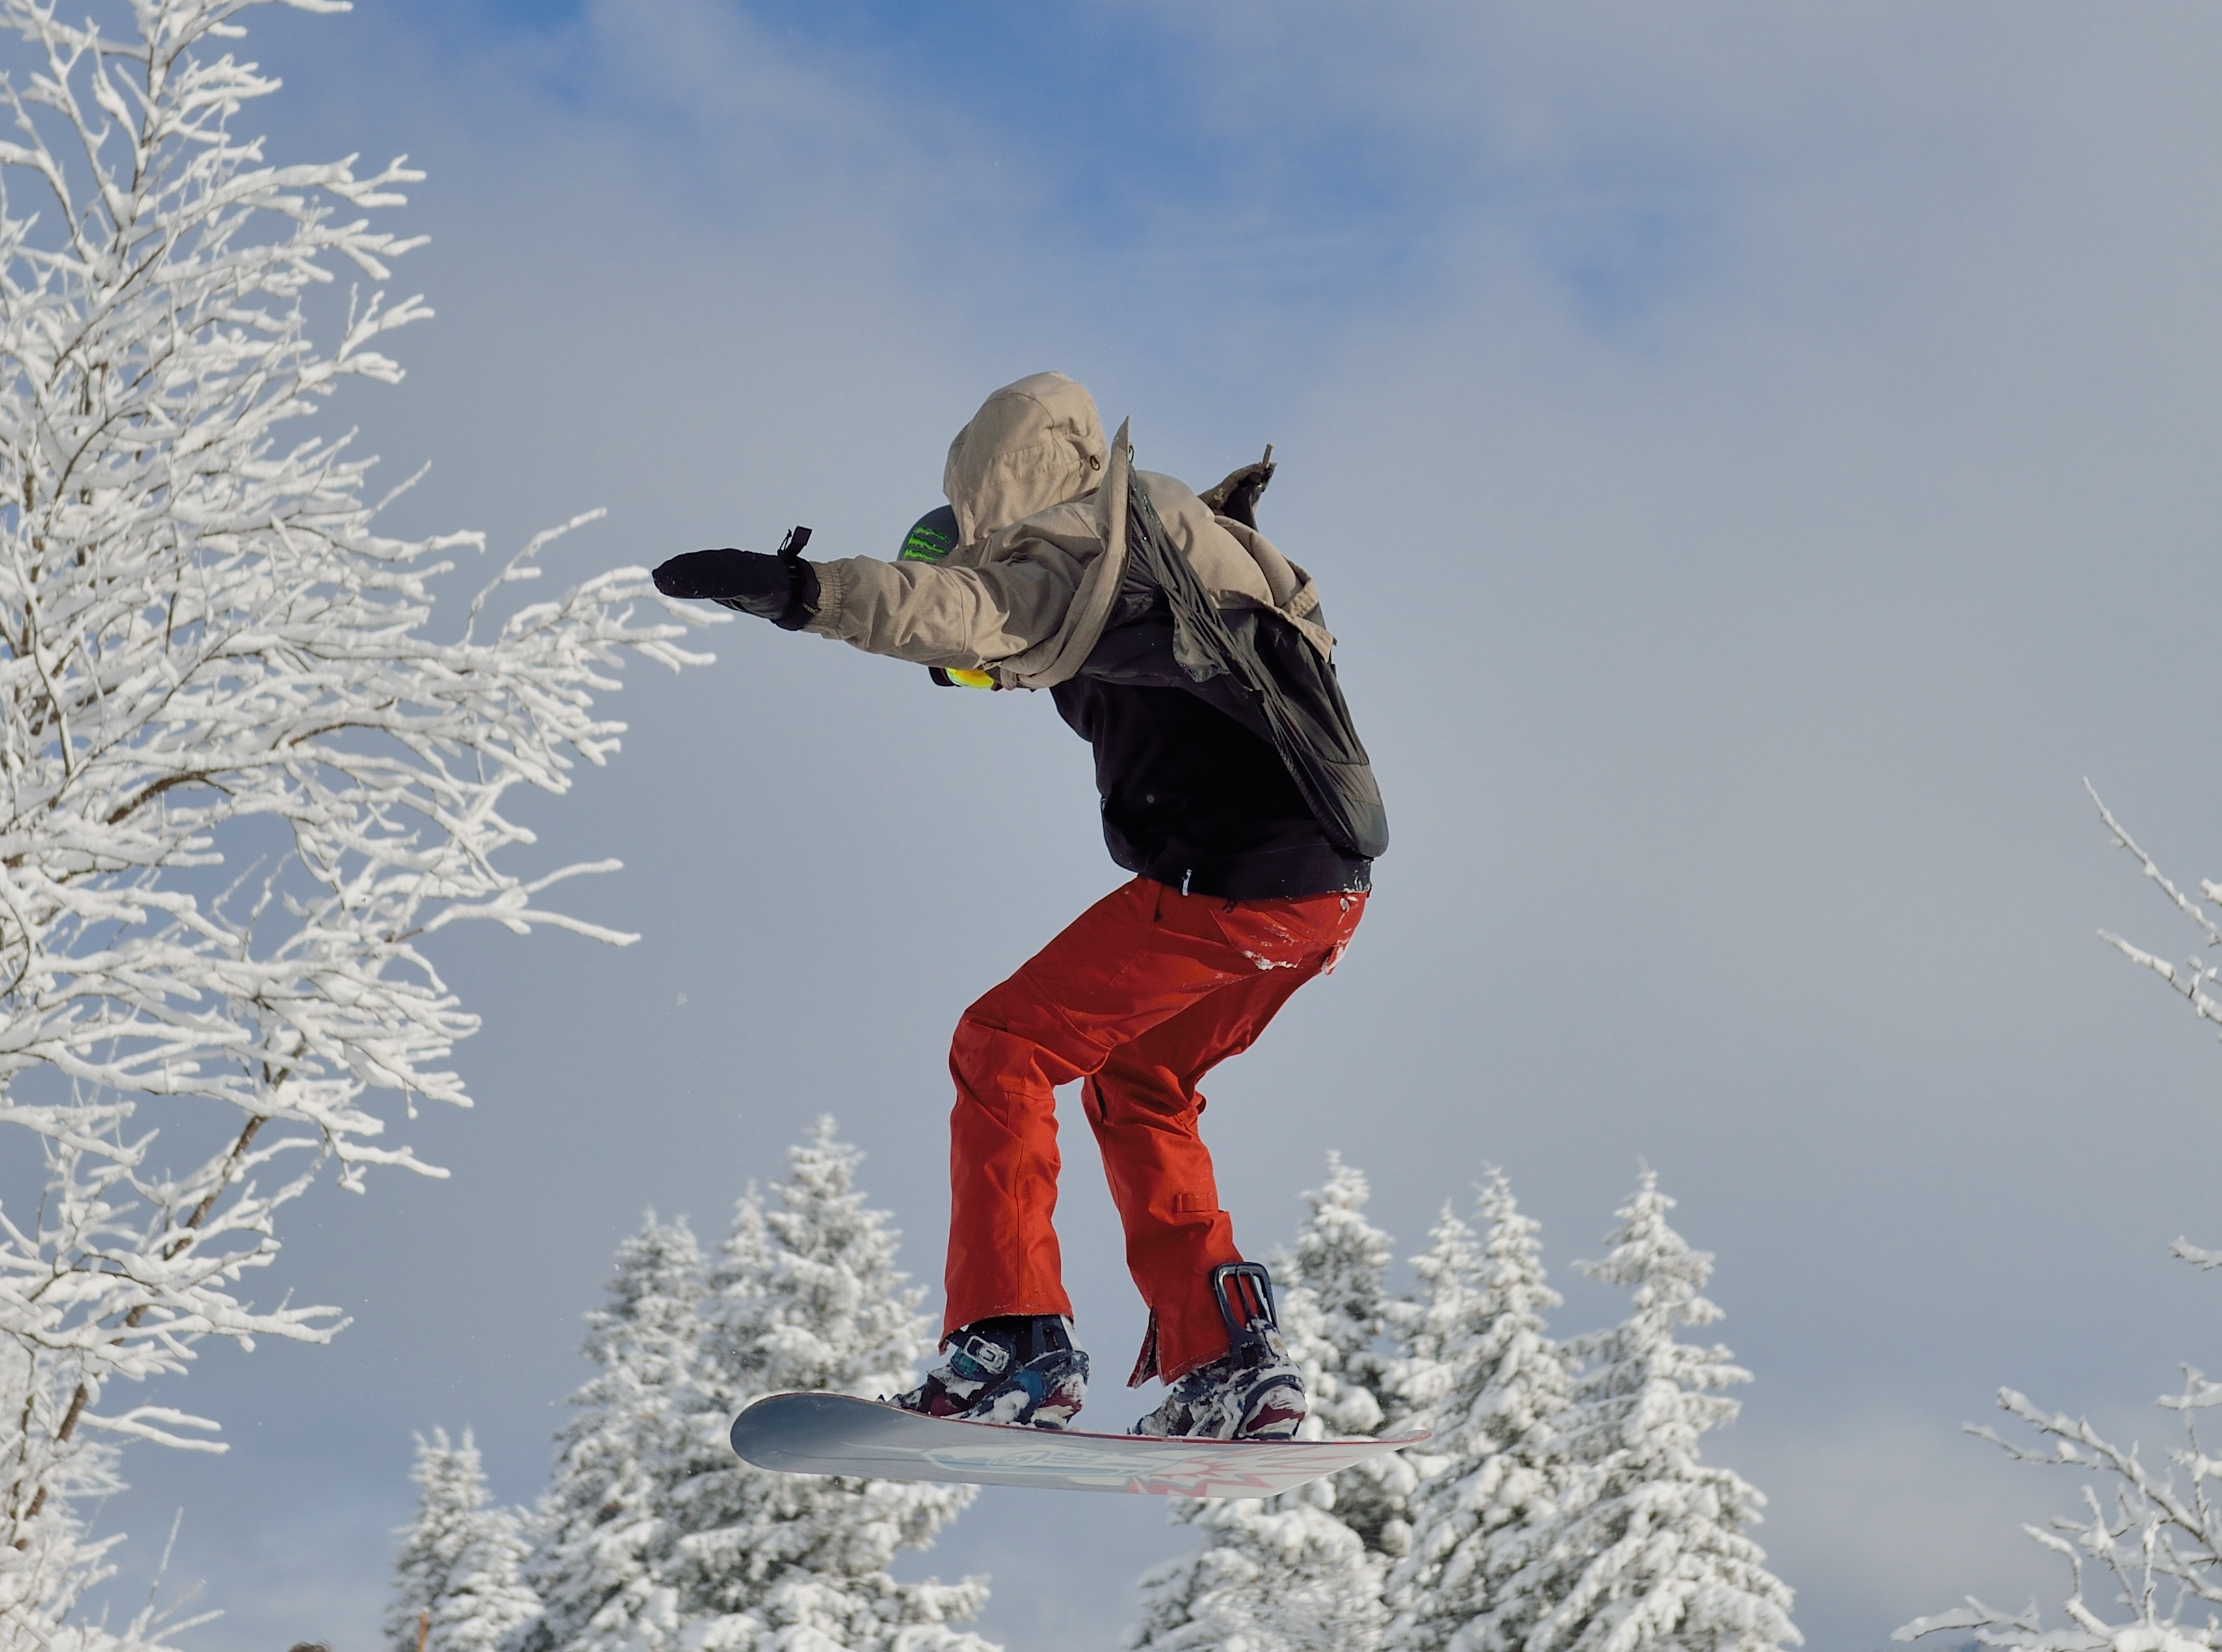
[0,0,718,1647]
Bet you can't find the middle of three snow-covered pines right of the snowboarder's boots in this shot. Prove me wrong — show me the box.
[1386,1168,1573,1652]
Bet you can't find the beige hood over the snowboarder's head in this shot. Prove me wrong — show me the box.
[942,373,1109,544]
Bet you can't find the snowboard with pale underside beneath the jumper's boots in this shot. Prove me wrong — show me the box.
[734,1395,1429,1497]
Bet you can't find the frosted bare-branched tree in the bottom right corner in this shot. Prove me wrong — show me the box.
[1893,1239,2222,1652]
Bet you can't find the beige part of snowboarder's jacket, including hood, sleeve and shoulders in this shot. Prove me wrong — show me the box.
[809,373,1336,688]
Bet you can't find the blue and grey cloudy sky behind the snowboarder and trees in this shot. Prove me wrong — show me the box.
[47,0,2222,1652]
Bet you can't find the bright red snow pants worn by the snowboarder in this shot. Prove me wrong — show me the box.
[942,877,1366,1381]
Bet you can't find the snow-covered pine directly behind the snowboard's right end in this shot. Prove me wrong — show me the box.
[1129,1153,1413,1652]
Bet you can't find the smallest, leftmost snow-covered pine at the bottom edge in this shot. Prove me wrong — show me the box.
[387,1428,538,1652]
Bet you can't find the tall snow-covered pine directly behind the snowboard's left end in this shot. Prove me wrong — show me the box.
[667,1119,993,1652]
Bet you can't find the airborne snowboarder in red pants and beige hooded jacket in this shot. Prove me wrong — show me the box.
[655,373,1389,1439]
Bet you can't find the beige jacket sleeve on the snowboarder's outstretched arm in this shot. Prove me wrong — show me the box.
[806,544,1080,670]
